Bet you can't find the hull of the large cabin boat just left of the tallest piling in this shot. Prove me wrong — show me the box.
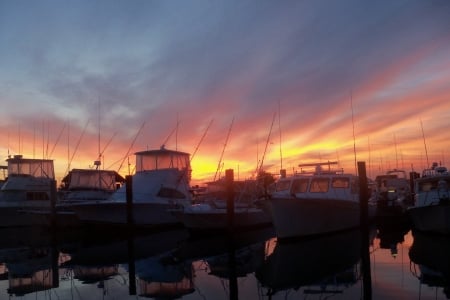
[270,198,361,239]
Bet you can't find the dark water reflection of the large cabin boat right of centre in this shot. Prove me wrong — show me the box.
[256,230,362,295]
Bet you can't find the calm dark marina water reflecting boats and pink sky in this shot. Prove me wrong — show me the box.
[0,220,450,300]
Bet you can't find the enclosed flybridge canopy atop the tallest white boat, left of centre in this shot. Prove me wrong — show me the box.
[135,148,191,172]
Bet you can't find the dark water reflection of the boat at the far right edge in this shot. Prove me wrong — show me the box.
[409,231,450,299]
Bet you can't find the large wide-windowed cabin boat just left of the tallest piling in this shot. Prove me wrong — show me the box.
[269,162,374,239]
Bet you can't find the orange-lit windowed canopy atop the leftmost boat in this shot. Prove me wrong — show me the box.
[6,155,55,179]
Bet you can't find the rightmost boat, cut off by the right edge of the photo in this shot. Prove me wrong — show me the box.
[407,163,450,234]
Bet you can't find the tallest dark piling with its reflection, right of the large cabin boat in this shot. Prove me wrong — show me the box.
[358,162,372,300]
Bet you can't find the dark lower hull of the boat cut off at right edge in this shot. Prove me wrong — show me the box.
[407,204,450,234]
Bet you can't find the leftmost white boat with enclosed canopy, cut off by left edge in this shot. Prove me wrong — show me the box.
[0,155,56,227]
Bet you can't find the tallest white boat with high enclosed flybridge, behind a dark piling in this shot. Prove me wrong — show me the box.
[71,147,192,226]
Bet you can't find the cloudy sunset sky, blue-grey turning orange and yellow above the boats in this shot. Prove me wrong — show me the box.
[0,0,450,182]
